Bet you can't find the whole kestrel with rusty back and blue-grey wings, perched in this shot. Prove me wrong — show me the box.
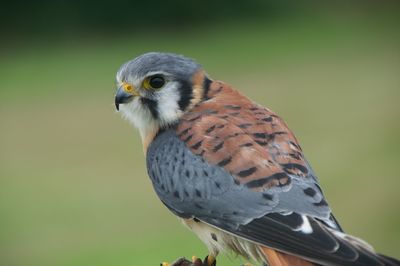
[114,52,400,266]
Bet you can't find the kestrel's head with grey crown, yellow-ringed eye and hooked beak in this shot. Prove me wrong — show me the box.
[115,52,210,141]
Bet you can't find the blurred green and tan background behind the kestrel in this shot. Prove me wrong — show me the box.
[0,0,400,266]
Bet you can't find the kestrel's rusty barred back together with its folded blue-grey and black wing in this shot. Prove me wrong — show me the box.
[147,83,396,265]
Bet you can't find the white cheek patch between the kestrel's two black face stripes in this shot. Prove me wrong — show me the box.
[157,81,182,125]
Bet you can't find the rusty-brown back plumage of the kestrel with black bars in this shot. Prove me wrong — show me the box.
[177,81,307,190]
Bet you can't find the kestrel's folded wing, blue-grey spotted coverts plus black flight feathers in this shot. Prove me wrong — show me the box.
[147,130,390,265]
